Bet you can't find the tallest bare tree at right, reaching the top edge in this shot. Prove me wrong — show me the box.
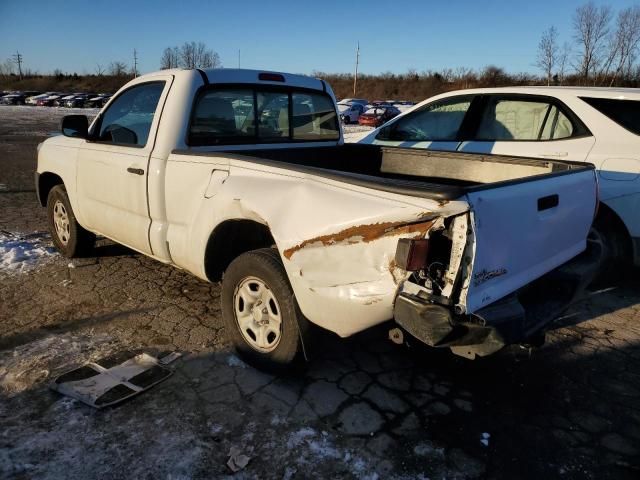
[573,2,611,82]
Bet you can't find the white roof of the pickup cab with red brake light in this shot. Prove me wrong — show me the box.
[138,68,331,91]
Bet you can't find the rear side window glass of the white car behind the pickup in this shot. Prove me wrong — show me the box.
[475,97,574,141]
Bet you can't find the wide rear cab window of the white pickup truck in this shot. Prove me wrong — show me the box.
[187,85,340,146]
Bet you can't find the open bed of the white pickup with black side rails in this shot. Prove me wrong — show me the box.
[179,144,593,200]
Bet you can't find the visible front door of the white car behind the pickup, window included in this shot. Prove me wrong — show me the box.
[372,95,475,151]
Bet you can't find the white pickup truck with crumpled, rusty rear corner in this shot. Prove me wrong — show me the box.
[36,69,597,367]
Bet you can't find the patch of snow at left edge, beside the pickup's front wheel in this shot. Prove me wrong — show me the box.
[0,231,57,274]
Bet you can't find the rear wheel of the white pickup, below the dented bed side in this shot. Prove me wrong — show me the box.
[220,248,301,371]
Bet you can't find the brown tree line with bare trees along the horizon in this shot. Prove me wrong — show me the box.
[0,1,640,101]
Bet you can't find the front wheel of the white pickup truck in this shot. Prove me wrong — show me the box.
[47,185,96,258]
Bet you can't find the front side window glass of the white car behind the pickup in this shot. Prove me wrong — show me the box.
[378,96,473,142]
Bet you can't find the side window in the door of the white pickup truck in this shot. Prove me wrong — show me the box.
[98,82,164,147]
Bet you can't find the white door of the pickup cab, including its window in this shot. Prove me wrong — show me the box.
[76,76,172,254]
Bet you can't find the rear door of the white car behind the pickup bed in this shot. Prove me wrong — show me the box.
[459,94,595,161]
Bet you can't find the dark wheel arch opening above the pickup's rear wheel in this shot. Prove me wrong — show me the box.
[204,219,276,282]
